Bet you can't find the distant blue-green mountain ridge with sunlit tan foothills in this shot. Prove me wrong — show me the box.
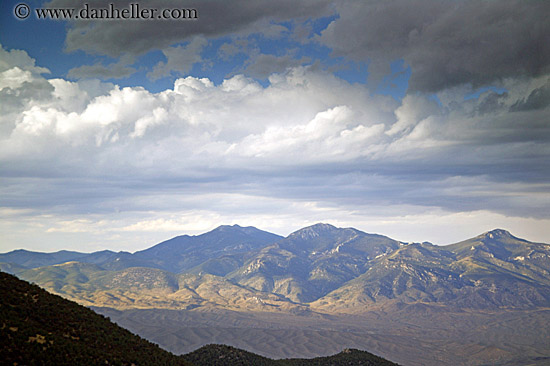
[0,223,550,313]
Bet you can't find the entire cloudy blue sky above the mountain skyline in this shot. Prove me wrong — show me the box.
[0,0,550,252]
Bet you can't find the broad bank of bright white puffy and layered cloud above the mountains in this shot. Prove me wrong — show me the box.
[0,43,550,250]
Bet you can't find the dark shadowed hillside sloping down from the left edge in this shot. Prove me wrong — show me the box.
[0,272,194,365]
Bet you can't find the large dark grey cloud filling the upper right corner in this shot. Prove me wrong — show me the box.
[319,0,550,92]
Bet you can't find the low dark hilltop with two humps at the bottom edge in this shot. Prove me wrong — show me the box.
[183,344,397,366]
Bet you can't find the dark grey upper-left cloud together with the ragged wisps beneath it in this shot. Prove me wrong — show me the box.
[42,0,333,81]
